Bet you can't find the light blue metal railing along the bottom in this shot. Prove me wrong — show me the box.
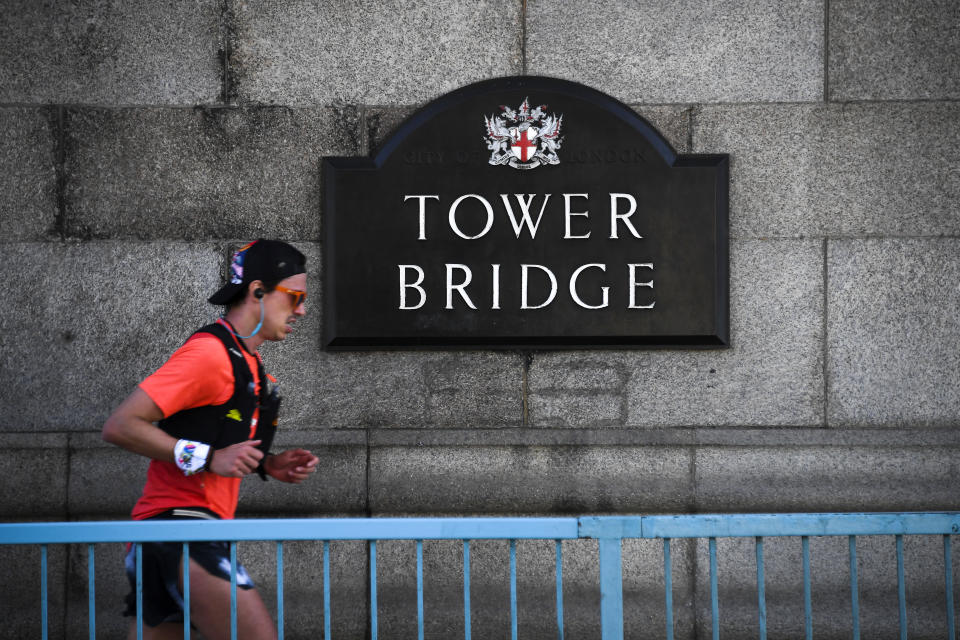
[0,512,960,640]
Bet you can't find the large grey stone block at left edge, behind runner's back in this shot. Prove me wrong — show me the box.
[0,242,222,432]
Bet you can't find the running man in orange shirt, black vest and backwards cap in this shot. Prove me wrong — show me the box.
[103,240,318,640]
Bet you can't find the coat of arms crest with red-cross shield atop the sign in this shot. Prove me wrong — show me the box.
[484,98,563,169]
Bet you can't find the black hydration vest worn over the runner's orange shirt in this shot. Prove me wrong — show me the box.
[157,323,280,454]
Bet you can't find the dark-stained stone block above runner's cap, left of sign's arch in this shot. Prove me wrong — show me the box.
[65,108,360,240]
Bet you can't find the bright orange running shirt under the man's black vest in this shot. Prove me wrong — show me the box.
[132,320,260,520]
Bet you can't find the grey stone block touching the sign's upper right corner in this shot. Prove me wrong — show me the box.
[693,102,960,237]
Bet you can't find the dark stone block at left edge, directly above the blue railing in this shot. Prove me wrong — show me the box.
[0,432,68,520]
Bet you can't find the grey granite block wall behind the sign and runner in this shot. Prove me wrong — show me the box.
[0,0,960,638]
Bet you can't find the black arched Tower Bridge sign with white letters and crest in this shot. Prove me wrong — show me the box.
[323,77,729,349]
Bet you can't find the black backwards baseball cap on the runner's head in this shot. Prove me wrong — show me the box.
[208,238,307,304]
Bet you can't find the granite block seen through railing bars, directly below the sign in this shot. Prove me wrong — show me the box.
[366,540,693,639]
